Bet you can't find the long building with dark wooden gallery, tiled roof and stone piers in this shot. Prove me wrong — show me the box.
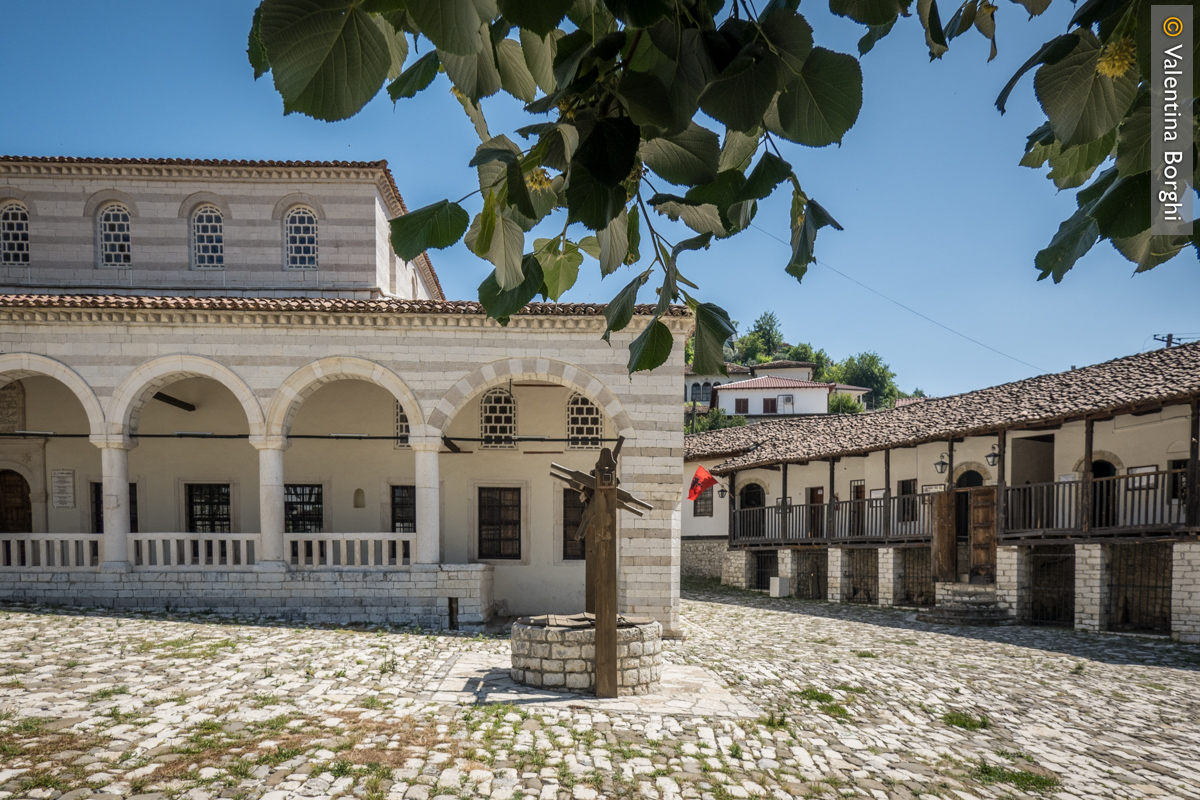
[683,343,1200,642]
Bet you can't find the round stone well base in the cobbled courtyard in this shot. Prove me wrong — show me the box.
[511,616,662,696]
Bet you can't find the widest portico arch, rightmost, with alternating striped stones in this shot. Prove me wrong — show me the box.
[428,359,635,439]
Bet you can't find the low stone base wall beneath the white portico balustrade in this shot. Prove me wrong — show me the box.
[0,564,494,630]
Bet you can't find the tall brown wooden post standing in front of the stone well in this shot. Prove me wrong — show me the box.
[592,447,617,697]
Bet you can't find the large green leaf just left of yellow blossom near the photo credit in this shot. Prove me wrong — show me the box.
[1033,29,1132,148]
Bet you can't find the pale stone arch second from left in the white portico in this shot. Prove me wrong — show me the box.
[108,354,266,437]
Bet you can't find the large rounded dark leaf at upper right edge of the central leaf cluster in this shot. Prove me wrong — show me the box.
[779,47,863,148]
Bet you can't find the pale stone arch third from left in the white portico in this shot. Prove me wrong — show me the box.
[266,356,425,438]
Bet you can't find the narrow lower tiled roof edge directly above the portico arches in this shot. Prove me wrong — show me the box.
[0,294,688,317]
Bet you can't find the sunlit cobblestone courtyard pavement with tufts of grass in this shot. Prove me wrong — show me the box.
[0,585,1200,800]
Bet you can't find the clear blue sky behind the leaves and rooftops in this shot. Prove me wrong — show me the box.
[0,0,1200,395]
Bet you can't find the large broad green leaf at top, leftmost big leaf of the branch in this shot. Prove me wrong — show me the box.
[258,0,391,121]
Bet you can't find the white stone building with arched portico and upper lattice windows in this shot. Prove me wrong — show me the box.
[0,157,690,633]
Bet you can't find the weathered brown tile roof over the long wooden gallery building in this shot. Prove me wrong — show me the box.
[684,343,1200,474]
